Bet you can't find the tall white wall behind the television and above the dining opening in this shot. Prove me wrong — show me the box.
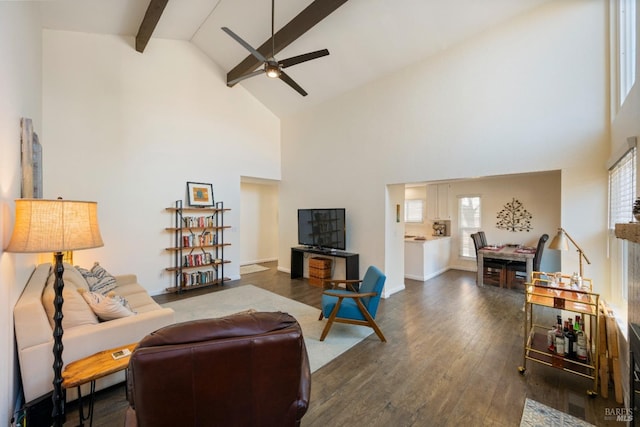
[279,0,608,296]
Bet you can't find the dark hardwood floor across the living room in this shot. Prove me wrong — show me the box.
[65,262,622,427]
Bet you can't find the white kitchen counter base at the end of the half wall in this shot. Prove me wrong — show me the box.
[404,236,451,282]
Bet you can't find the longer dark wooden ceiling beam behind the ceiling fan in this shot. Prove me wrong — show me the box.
[227,0,348,86]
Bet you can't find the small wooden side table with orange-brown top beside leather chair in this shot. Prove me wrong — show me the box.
[62,343,138,426]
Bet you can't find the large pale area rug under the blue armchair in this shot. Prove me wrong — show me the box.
[162,285,373,372]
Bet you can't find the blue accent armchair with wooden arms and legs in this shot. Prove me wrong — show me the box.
[318,266,387,342]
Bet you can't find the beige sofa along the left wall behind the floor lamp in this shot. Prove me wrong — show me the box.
[13,263,174,402]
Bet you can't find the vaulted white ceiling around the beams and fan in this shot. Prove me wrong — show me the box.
[41,0,558,117]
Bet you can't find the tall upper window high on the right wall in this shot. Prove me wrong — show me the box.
[616,0,636,105]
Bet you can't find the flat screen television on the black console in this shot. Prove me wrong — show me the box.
[298,208,347,250]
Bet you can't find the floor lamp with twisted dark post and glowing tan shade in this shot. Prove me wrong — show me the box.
[5,199,103,426]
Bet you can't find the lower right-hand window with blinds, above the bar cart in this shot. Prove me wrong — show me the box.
[609,147,636,306]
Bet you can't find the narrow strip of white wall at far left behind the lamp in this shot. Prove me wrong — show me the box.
[0,2,42,425]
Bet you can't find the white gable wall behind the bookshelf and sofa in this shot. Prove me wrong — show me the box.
[42,30,280,294]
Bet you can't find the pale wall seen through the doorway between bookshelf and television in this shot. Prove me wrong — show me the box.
[239,178,279,265]
